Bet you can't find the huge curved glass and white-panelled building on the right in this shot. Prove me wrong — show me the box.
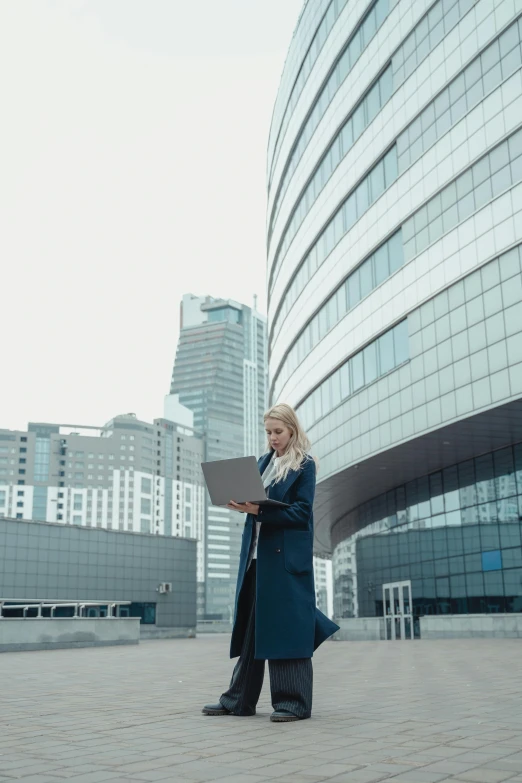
[267,0,522,618]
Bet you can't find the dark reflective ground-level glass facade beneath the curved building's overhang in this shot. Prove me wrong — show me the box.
[332,443,522,617]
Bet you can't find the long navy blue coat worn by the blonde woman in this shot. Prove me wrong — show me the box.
[230,452,339,660]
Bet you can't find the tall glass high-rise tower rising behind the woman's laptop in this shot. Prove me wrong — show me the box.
[171,294,267,622]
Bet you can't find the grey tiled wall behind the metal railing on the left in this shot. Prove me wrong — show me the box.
[0,518,196,631]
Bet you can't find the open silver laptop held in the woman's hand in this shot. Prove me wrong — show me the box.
[201,457,289,508]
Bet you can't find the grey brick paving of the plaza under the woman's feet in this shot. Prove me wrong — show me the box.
[0,635,522,783]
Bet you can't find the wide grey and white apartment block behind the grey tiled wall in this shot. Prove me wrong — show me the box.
[0,395,205,596]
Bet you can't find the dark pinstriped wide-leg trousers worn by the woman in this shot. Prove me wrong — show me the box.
[219,560,313,718]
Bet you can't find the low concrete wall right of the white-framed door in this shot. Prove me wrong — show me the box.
[419,614,522,639]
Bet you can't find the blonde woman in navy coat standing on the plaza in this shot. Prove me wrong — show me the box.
[199,405,338,722]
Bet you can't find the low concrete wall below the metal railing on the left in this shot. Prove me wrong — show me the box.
[0,617,140,652]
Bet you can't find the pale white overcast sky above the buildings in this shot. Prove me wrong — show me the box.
[0,0,302,429]
